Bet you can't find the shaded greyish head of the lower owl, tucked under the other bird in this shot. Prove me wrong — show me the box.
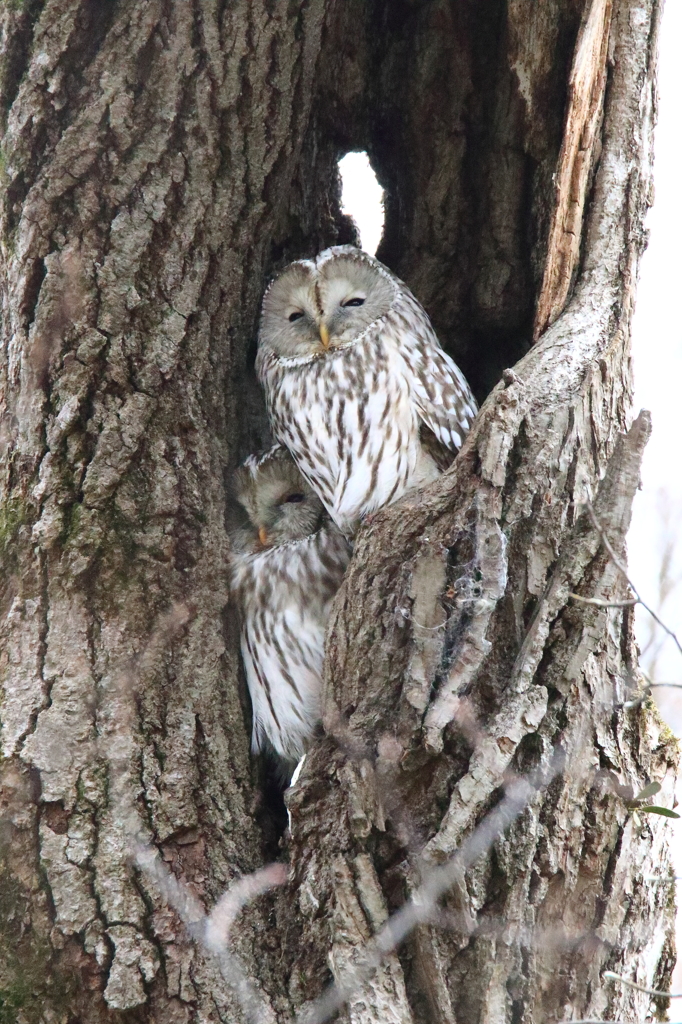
[231,446,326,554]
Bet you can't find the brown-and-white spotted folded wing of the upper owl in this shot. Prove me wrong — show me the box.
[400,330,478,452]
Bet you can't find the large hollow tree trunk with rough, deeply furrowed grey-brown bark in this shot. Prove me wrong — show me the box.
[0,0,675,1024]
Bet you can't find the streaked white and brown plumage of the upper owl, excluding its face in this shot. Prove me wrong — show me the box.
[256,247,477,536]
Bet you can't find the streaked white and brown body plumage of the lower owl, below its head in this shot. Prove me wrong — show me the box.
[231,523,350,760]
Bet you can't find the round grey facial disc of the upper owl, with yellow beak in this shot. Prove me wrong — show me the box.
[259,246,396,357]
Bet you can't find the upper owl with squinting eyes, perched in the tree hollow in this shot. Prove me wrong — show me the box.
[251,246,476,536]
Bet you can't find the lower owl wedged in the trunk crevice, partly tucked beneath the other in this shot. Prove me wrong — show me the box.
[230,445,350,761]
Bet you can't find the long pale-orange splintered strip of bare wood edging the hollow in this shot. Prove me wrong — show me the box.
[534,0,612,341]
